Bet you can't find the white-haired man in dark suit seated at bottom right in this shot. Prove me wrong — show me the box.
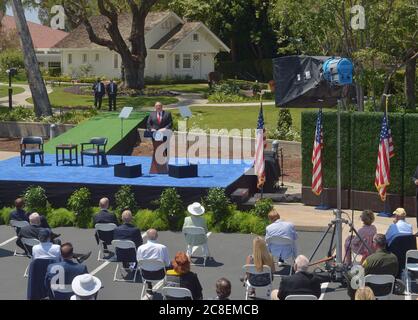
[271,255,321,300]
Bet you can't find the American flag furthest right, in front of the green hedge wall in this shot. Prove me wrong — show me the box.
[374,114,395,201]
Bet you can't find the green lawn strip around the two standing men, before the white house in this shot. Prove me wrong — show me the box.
[28,87,178,109]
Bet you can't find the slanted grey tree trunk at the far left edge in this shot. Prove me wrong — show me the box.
[13,0,52,117]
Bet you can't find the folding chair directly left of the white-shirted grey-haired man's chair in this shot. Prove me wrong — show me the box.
[112,240,138,282]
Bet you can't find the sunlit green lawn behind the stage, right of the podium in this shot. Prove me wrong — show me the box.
[174,106,334,132]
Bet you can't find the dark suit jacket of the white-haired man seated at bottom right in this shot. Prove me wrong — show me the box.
[278,272,321,300]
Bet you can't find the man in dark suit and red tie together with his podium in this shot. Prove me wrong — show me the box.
[147,102,173,174]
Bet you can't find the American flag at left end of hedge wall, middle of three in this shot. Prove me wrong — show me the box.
[312,109,324,196]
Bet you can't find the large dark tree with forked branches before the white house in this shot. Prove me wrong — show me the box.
[62,0,158,89]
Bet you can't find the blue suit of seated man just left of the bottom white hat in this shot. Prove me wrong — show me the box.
[45,260,88,300]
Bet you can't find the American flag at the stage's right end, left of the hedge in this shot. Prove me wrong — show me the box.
[254,105,267,189]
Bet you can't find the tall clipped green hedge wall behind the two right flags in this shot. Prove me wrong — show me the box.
[302,111,418,196]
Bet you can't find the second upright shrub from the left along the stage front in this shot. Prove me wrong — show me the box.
[67,188,93,228]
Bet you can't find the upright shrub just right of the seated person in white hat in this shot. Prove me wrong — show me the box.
[203,188,230,225]
